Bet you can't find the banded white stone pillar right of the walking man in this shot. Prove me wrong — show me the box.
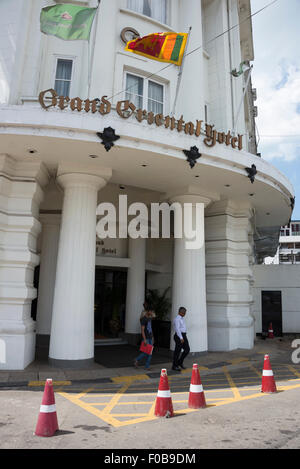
[205,200,254,351]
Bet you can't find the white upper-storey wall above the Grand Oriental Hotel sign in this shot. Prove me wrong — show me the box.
[0,0,243,132]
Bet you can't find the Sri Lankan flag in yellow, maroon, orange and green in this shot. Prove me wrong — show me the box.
[125,33,188,66]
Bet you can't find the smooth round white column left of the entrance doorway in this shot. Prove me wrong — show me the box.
[49,172,106,367]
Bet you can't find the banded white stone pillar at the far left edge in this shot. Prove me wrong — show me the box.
[0,155,49,370]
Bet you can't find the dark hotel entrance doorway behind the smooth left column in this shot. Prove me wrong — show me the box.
[95,267,127,339]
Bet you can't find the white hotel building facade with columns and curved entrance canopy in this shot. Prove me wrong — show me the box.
[0,0,294,369]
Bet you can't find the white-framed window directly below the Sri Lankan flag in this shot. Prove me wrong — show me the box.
[125,73,164,114]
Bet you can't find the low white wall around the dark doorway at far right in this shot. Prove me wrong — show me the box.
[253,265,300,333]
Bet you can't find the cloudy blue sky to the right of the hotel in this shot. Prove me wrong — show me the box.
[251,0,300,220]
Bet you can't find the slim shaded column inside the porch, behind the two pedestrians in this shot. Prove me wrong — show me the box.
[125,238,146,340]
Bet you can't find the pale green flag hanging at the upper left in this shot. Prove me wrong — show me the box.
[40,4,97,41]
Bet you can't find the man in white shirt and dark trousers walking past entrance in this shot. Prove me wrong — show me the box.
[172,306,190,371]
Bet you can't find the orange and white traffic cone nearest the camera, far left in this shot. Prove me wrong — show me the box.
[35,379,58,436]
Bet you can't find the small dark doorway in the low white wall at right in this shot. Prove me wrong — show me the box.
[261,291,282,337]
